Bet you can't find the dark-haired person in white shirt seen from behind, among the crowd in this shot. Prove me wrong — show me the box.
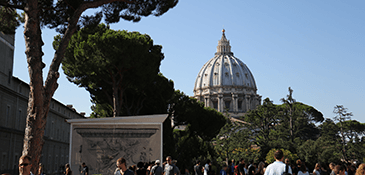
[264,150,292,175]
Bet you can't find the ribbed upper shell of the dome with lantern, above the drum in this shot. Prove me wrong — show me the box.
[194,32,257,91]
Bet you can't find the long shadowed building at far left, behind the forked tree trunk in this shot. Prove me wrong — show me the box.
[0,32,84,174]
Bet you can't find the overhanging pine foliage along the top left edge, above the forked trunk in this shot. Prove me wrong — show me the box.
[0,0,178,33]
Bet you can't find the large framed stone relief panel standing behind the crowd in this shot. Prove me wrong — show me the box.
[67,114,167,175]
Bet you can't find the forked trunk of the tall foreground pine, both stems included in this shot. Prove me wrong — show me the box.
[22,0,82,172]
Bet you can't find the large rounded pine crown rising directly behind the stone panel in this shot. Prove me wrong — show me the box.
[54,24,166,116]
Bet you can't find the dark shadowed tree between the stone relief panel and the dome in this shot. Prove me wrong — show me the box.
[164,90,226,172]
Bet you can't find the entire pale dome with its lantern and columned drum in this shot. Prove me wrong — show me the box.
[194,30,261,116]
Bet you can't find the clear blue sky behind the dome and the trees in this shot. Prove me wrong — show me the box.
[13,0,365,123]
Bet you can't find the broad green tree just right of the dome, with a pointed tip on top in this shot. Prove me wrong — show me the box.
[244,88,324,160]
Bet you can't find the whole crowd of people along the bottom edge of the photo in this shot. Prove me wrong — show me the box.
[4,150,365,175]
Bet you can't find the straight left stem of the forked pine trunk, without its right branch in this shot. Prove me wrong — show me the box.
[22,0,50,174]
